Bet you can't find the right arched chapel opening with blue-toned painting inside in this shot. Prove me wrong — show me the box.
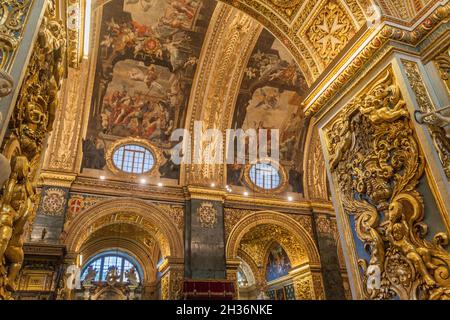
[227,212,322,300]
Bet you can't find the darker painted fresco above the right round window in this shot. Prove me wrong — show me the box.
[228,30,308,193]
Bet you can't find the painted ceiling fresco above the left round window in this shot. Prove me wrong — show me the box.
[83,0,216,179]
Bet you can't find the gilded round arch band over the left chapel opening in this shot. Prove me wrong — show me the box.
[64,198,183,258]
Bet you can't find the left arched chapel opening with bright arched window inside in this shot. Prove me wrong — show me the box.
[64,199,183,299]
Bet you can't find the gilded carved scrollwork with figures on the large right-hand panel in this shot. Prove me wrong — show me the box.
[326,69,450,299]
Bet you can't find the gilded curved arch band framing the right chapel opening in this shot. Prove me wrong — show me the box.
[226,211,320,267]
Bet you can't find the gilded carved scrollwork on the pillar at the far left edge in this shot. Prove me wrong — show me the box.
[0,1,66,299]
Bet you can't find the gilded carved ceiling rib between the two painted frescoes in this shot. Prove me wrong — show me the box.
[186,9,261,186]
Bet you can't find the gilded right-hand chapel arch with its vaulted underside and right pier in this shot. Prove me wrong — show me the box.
[226,211,323,300]
